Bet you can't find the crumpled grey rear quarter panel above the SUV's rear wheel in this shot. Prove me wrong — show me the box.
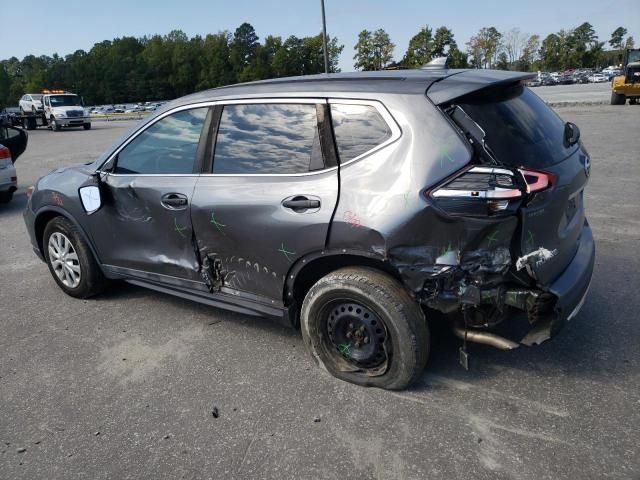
[329,96,518,294]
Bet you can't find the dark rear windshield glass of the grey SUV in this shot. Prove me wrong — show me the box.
[456,84,578,168]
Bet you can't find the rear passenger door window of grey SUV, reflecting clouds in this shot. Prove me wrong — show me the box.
[213,103,324,174]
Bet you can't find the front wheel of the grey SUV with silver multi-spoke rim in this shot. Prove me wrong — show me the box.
[42,217,106,298]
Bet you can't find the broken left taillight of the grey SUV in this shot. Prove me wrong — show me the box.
[427,166,522,216]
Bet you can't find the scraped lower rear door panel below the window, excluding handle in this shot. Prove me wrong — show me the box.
[191,168,338,302]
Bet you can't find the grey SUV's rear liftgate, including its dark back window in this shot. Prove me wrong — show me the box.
[453,83,590,285]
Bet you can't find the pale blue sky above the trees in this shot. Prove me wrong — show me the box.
[0,0,640,71]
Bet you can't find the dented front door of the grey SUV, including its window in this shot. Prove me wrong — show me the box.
[88,107,209,280]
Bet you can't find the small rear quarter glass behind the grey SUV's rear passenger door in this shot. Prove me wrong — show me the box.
[331,103,391,163]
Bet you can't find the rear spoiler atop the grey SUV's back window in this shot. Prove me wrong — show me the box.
[427,70,537,105]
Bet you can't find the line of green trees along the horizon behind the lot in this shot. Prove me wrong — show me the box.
[0,22,634,105]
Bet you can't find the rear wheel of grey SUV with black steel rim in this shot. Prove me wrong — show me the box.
[300,267,430,390]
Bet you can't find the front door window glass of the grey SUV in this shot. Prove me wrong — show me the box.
[115,107,208,174]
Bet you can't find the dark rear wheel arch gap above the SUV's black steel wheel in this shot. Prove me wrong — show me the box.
[283,249,404,323]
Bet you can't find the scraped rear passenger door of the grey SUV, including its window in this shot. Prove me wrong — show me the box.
[191,99,338,303]
